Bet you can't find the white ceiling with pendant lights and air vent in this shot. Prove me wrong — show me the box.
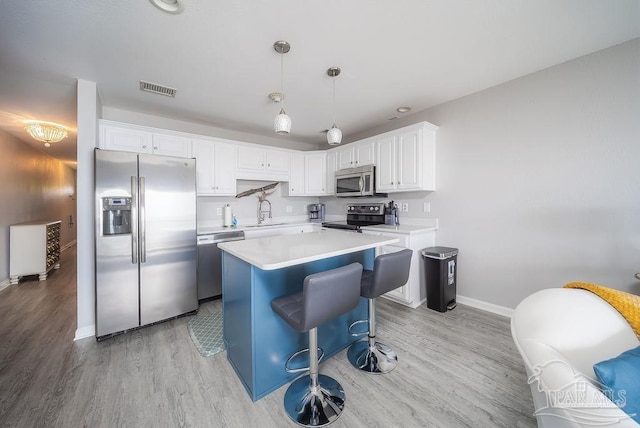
[0,0,640,163]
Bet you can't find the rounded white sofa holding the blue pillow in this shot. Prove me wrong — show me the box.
[511,288,640,428]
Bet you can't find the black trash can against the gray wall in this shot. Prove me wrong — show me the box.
[422,247,458,312]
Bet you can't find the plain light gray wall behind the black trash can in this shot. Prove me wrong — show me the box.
[354,39,640,308]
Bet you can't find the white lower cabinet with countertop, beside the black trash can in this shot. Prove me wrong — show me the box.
[362,231,435,308]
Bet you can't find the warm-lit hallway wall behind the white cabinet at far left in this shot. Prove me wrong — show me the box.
[0,129,76,287]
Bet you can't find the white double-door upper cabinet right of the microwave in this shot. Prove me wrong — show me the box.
[375,122,438,192]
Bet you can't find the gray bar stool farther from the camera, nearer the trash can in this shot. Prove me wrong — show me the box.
[347,249,413,374]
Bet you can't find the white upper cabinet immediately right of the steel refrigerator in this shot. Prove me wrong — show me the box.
[192,140,237,196]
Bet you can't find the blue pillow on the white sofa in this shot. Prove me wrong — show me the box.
[593,346,640,423]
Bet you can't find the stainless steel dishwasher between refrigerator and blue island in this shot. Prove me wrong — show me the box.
[198,231,244,300]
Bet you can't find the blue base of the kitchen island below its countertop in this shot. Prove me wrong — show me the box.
[223,249,374,401]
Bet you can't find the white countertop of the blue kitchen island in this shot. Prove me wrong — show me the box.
[218,230,398,270]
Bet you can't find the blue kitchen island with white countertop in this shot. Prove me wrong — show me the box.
[219,230,398,401]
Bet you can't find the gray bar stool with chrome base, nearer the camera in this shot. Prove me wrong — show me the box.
[271,263,362,427]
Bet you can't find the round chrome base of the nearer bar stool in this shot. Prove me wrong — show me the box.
[284,374,345,427]
